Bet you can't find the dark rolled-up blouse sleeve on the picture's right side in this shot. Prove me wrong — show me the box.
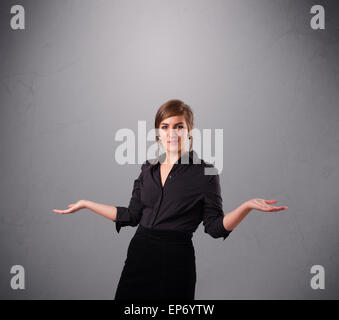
[202,174,232,240]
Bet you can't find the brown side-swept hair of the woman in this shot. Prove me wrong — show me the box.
[154,99,194,151]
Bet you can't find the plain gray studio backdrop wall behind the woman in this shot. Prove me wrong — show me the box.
[0,0,339,299]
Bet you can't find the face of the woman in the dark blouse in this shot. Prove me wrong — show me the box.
[159,116,189,153]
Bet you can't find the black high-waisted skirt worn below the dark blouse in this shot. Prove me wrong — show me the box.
[114,224,196,301]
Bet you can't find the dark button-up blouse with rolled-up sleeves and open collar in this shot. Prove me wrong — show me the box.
[115,150,232,240]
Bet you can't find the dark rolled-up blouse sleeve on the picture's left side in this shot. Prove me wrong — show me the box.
[115,163,146,232]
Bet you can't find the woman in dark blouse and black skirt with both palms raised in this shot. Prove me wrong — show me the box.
[53,100,287,300]
